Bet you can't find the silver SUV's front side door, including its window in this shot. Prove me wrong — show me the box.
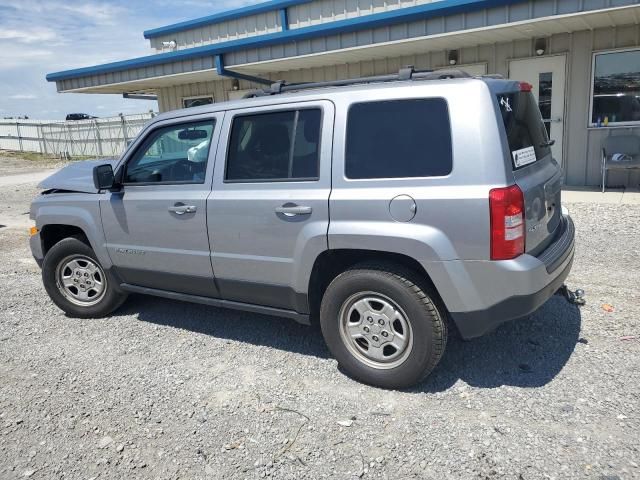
[100,115,222,297]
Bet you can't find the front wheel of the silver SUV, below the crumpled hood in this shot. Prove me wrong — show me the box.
[42,237,127,318]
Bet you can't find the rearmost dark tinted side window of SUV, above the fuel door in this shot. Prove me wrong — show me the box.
[345,98,453,179]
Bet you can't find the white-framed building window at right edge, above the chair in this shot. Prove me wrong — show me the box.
[590,50,640,126]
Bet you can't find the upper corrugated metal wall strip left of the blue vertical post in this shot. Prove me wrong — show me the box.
[150,11,282,52]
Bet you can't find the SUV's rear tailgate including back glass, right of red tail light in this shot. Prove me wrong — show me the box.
[496,88,562,255]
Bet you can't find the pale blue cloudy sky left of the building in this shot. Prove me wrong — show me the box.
[0,0,262,120]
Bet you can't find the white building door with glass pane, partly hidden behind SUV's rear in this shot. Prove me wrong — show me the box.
[509,55,566,165]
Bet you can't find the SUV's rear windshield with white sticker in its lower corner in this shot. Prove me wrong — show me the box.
[497,92,551,169]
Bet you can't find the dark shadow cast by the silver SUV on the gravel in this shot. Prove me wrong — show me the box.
[119,295,581,392]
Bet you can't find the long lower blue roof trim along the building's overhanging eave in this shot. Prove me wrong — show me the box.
[46,0,527,82]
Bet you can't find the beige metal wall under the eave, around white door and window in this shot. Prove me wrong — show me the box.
[159,25,640,185]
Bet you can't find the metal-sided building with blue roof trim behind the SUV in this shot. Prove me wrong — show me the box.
[47,0,640,186]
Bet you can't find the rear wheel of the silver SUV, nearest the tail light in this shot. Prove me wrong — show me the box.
[320,265,447,388]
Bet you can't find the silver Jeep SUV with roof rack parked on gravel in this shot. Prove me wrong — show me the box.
[31,69,574,388]
